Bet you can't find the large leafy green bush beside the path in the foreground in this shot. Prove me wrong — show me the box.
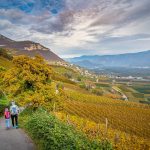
[21,110,112,150]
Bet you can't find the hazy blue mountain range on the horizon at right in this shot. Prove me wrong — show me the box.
[68,50,150,69]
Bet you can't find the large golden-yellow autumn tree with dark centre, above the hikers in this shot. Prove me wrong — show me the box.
[1,55,59,109]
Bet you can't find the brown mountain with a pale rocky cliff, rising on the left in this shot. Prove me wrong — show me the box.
[0,34,63,61]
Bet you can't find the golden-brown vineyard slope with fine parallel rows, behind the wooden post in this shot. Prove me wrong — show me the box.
[65,91,150,139]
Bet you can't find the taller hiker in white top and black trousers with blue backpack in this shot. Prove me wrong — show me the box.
[10,101,19,128]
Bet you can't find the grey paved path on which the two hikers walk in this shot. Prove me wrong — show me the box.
[0,118,35,150]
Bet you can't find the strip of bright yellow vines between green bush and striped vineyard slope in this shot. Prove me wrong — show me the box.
[55,112,150,150]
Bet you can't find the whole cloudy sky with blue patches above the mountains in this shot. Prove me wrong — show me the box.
[0,0,150,57]
